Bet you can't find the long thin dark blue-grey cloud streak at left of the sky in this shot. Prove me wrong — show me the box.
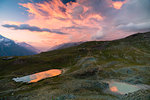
[2,24,65,34]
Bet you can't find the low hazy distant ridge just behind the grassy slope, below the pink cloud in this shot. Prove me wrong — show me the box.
[50,42,83,51]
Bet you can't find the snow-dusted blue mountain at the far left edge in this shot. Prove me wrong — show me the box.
[0,35,37,56]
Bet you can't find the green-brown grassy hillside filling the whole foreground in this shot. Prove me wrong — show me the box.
[0,32,150,100]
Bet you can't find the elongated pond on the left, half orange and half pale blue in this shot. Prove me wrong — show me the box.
[13,69,62,83]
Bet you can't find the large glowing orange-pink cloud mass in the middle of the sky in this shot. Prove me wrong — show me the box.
[17,0,103,46]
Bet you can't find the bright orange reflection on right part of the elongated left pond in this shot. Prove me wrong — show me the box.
[29,69,62,83]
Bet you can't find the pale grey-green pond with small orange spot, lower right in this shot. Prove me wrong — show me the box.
[106,81,150,95]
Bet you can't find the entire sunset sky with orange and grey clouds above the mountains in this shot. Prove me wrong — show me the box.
[0,0,150,51]
